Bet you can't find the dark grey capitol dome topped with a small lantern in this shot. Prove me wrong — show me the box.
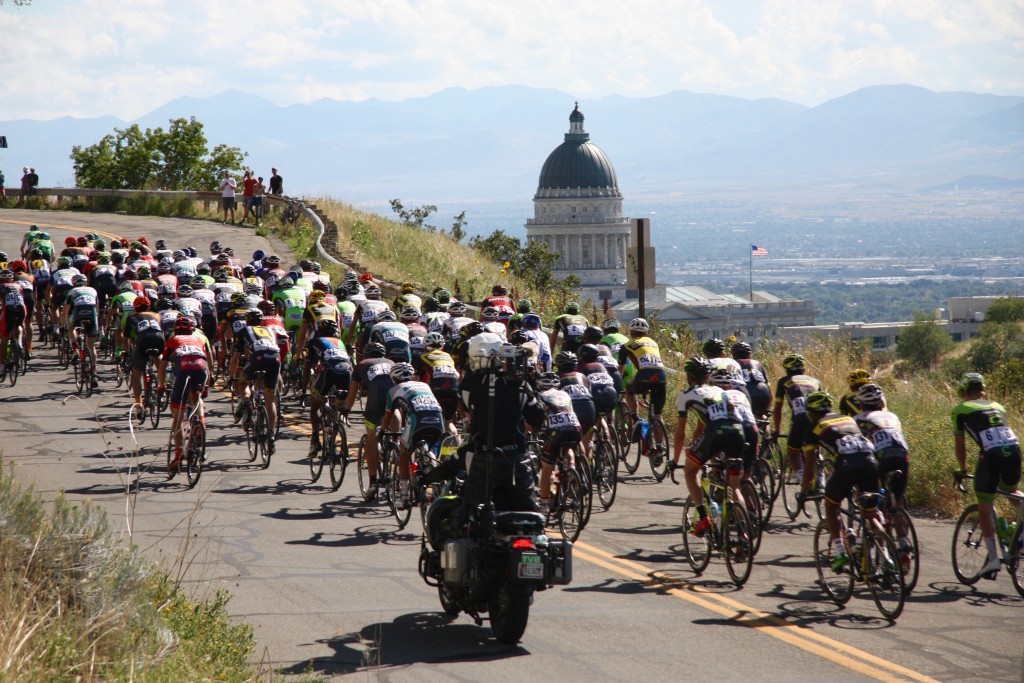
[537,102,622,198]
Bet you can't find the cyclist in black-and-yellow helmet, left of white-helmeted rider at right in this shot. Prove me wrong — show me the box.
[798,390,876,571]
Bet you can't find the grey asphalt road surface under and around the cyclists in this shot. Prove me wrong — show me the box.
[0,210,1024,681]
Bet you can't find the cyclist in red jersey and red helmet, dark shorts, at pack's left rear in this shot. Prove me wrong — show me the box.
[157,315,211,475]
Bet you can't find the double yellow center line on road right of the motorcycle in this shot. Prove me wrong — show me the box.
[573,542,937,683]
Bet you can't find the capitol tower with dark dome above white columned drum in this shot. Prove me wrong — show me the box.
[526,102,630,304]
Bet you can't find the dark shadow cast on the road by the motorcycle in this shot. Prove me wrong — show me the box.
[278,612,529,678]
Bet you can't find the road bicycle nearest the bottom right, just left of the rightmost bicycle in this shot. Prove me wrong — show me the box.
[814,493,906,620]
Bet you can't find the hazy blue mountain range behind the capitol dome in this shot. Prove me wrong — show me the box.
[0,85,1024,203]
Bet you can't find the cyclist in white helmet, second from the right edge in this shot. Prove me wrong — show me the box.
[853,382,912,570]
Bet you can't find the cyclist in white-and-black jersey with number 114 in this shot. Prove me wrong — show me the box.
[669,355,745,537]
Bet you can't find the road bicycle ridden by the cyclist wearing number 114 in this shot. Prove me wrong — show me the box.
[670,454,756,588]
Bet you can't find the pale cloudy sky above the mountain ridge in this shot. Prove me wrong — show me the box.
[0,0,1024,121]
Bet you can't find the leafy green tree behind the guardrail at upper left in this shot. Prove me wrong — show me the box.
[71,118,247,189]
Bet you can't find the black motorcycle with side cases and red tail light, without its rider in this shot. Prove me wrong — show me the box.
[419,483,572,644]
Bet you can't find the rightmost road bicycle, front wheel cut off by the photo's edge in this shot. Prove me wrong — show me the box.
[952,472,1024,597]
